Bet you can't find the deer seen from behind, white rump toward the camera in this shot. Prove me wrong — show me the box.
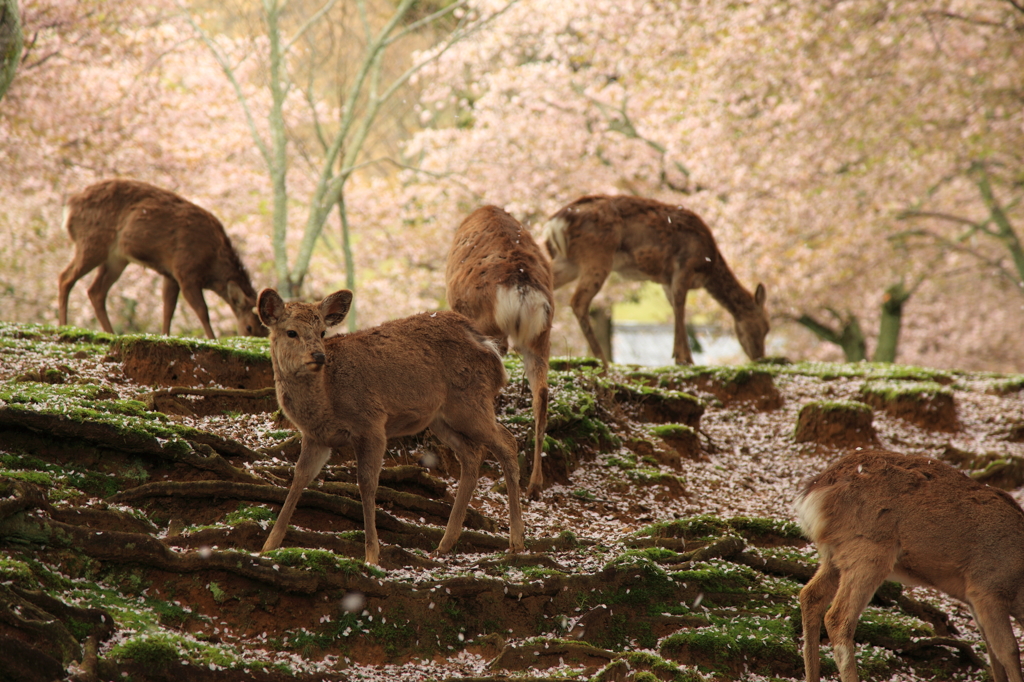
[445,206,555,500]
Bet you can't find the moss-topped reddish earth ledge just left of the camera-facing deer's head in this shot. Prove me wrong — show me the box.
[111,335,273,389]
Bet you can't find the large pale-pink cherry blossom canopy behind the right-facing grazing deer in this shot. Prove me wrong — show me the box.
[397,0,1024,364]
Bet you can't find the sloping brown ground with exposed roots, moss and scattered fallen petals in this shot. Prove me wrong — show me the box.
[0,325,1024,682]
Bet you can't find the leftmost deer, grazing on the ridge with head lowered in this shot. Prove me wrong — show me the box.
[58,178,266,339]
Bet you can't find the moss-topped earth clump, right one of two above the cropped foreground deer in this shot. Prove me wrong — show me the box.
[860,381,961,432]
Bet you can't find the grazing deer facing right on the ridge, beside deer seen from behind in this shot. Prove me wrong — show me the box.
[543,195,769,371]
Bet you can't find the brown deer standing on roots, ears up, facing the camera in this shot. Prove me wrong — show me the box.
[256,289,525,564]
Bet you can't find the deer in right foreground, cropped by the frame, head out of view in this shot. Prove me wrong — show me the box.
[797,451,1024,682]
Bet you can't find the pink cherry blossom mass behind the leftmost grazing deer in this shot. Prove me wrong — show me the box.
[0,0,268,333]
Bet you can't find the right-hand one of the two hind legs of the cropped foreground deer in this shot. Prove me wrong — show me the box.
[825,541,896,682]
